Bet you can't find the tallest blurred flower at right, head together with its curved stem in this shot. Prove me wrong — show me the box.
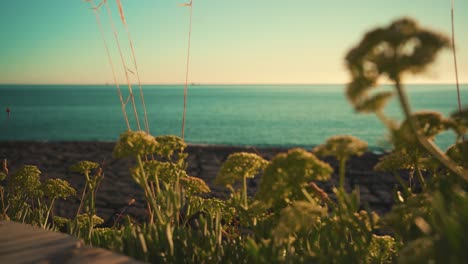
[346,18,468,181]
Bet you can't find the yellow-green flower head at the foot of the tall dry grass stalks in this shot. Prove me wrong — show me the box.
[112,131,159,158]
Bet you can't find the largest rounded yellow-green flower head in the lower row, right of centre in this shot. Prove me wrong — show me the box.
[256,149,333,206]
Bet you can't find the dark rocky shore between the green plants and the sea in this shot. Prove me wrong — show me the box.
[0,142,397,224]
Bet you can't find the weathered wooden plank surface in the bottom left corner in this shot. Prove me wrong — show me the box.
[0,221,142,264]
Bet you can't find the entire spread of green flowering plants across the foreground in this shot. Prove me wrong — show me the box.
[0,16,468,263]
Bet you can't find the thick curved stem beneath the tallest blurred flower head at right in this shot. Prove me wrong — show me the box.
[395,78,468,182]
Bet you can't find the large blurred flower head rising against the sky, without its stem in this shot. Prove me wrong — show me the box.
[346,18,450,92]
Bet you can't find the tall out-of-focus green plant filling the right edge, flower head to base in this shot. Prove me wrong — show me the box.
[346,19,468,263]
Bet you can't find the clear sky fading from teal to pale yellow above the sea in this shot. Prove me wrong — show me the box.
[0,0,468,84]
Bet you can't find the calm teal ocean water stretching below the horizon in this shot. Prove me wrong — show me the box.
[0,85,468,151]
